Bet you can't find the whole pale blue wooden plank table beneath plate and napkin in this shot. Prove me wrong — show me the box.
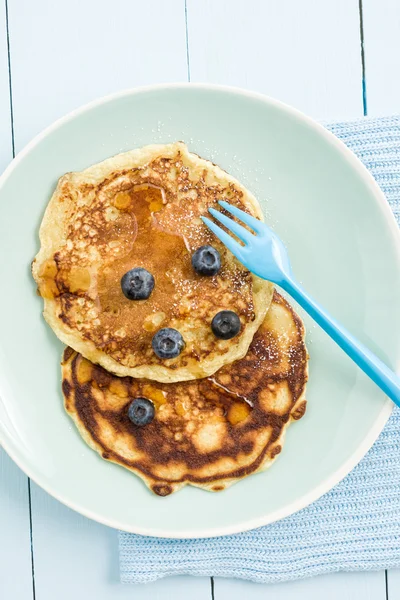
[0,0,400,600]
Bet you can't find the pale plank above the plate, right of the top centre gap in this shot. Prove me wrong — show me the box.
[188,0,362,119]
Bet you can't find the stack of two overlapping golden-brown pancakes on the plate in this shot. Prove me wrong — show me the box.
[32,142,307,496]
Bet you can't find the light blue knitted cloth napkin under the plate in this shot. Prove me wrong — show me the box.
[119,116,400,583]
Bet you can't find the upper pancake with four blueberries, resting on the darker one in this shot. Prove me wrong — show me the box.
[32,142,273,382]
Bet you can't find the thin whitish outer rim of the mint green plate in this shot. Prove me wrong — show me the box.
[0,83,400,539]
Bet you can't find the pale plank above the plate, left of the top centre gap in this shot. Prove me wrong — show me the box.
[8,0,187,149]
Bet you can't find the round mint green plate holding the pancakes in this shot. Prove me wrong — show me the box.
[0,85,400,537]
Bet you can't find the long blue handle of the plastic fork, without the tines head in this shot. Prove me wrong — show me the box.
[281,279,400,406]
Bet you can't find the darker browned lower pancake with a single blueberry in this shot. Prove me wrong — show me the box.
[62,292,308,496]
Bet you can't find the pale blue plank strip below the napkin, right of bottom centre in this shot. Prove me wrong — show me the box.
[214,571,386,600]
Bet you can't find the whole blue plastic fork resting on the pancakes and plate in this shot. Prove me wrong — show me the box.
[202,201,400,406]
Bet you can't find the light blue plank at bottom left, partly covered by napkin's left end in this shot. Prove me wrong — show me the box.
[32,484,211,600]
